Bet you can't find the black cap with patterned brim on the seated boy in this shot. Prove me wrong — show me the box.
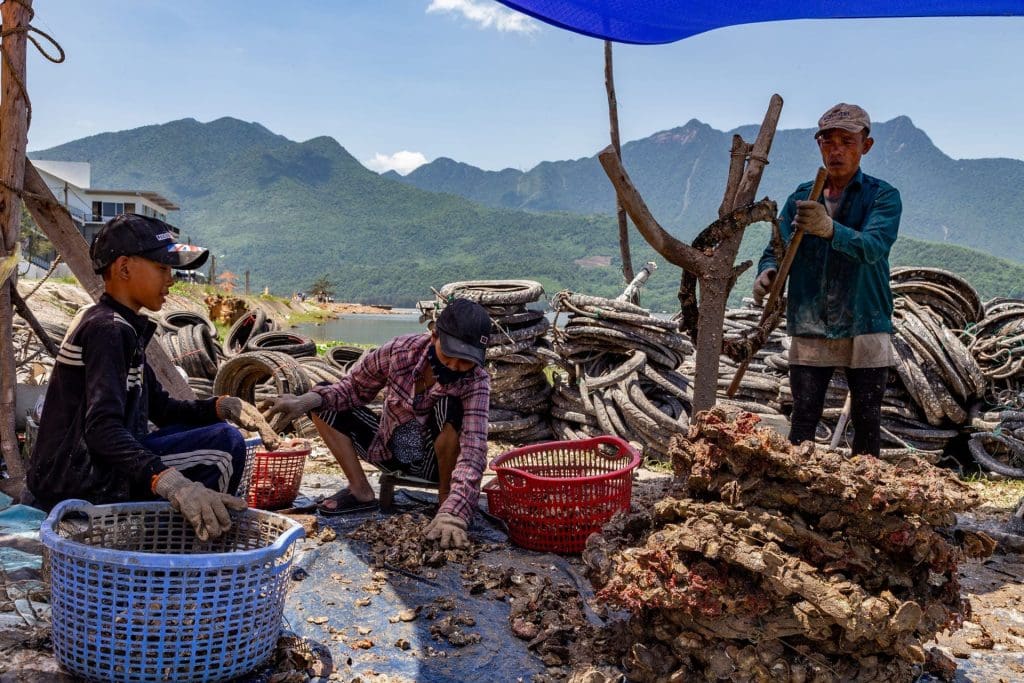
[89,213,210,272]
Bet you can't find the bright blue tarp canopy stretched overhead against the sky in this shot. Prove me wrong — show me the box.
[498,0,1024,44]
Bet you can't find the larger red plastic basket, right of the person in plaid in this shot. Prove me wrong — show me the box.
[483,436,640,553]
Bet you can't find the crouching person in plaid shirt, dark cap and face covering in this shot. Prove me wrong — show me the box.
[261,299,490,548]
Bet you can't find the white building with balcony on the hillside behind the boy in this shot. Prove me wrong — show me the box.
[32,159,180,244]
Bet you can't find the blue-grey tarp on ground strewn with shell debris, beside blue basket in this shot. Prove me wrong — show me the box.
[246,490,597,683]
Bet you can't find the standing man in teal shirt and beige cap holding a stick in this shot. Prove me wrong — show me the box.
[754,102,903,456]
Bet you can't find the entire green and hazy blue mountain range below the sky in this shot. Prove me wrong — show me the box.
[30,118,1024,310]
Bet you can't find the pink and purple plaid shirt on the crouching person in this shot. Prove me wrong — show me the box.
[313,334,490,522]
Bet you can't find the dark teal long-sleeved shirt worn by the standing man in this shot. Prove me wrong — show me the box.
[758,169,903,339]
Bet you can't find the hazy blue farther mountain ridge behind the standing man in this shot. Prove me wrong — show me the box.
[393,117,1024,261]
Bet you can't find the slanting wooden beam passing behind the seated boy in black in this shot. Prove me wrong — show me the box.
[23,161,196,398]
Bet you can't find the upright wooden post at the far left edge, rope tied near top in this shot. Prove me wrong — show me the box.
[0,0,32,491]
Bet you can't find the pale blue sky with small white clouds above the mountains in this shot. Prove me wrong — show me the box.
[22,0,1024,173]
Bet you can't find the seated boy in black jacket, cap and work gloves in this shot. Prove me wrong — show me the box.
[28,214,275,541]
